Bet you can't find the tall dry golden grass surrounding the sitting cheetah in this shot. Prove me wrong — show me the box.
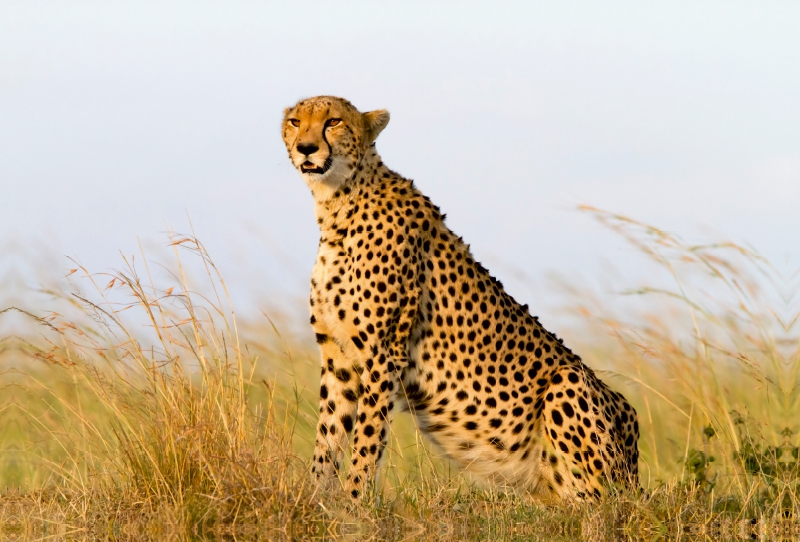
[0,209,800,540]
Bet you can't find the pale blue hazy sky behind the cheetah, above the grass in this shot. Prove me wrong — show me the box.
[0,0,800,318]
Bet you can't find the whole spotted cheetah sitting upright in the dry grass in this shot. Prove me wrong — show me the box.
[282,96,639,501]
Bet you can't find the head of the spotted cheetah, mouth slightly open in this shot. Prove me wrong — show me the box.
[282,96,389,200]
